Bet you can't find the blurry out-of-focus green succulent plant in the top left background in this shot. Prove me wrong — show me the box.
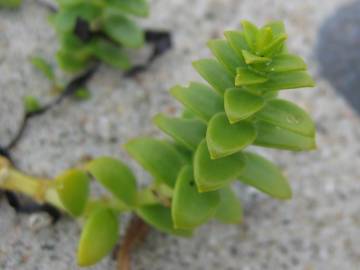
[51,0,149,72]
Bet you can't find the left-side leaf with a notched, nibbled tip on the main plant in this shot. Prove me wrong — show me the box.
[170,83,224,122]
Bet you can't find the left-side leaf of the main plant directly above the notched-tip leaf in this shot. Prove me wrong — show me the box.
[193,59,234,95]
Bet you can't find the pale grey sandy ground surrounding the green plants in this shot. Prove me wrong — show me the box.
[0,0,360,270]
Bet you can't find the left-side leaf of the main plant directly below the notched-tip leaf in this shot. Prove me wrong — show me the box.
[154,114,206,151]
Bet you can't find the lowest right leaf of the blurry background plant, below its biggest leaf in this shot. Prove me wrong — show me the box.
[90,39,131,70]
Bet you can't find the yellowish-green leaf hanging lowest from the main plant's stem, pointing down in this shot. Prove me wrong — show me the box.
[77,208,118,266]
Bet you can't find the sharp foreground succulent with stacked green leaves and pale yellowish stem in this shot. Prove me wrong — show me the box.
[0,21,315,266]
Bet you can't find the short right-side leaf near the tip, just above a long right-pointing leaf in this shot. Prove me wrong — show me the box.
[267,54,306,72]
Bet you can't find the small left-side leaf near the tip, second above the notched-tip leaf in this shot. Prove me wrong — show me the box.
[208,39,246,76]
